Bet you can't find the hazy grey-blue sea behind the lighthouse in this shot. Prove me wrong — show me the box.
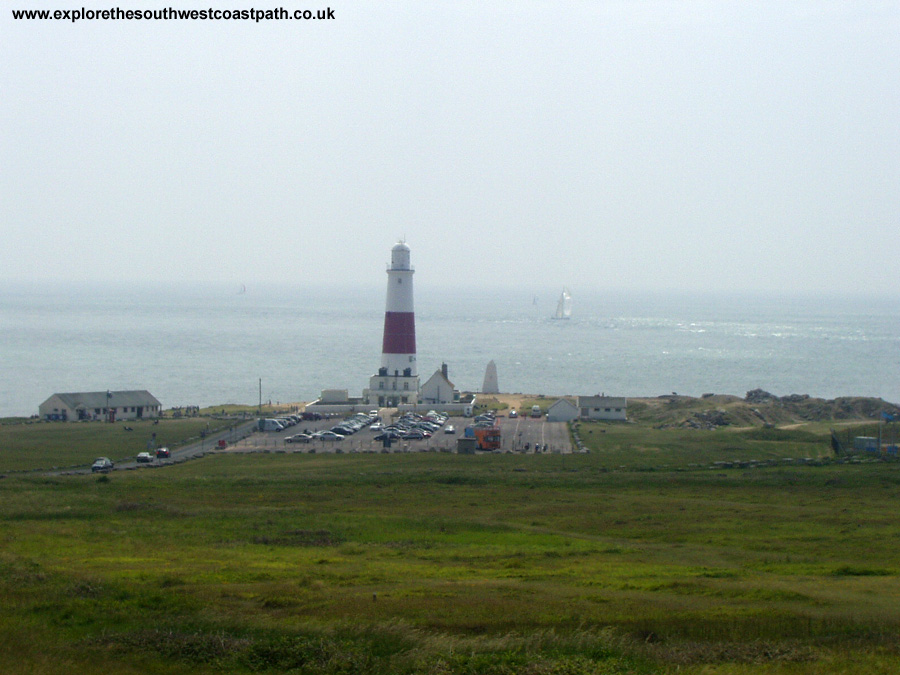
[0,284,900,417]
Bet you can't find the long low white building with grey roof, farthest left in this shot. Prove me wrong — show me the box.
[38,390,162,422]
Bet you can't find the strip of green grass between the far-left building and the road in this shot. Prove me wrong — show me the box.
[0,417,235,473]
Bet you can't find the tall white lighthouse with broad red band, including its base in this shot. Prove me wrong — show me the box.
[366,242,419,407]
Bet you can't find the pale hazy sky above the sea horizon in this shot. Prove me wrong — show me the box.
[0,0,900,294]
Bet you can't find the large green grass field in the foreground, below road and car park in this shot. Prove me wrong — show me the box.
[0,414,900,675]
